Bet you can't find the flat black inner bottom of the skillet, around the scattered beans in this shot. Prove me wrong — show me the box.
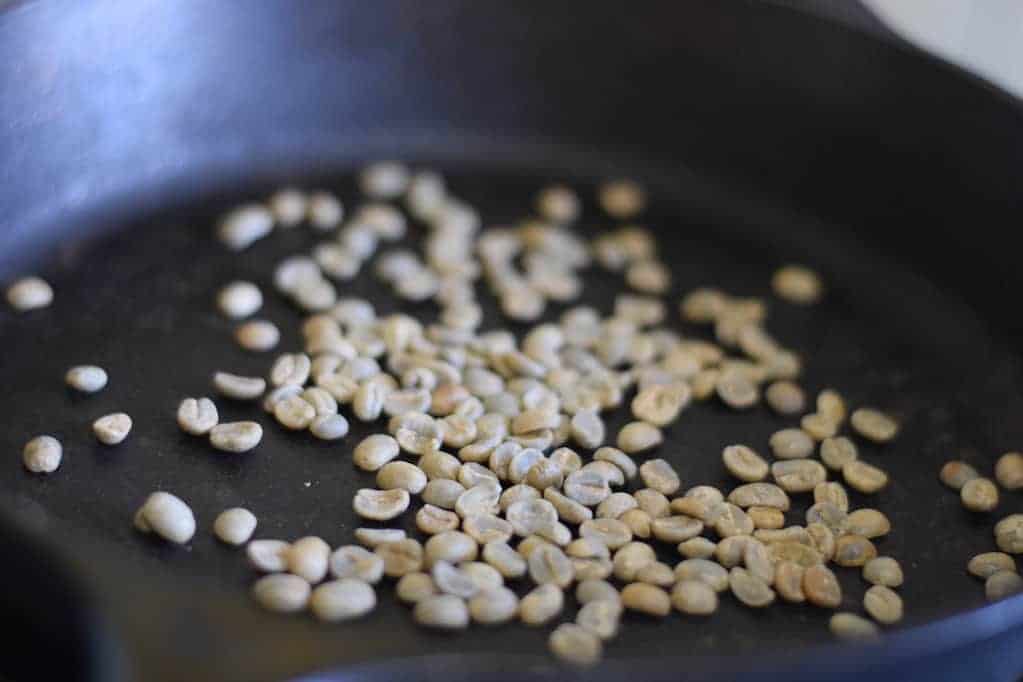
[0,154,1023,679]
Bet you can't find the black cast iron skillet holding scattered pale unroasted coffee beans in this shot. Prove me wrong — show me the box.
[0,0,1023,681]
